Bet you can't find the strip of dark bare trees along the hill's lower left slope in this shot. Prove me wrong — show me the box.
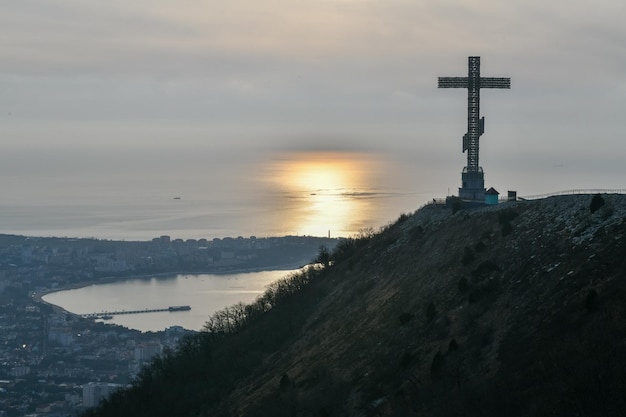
[85,266,332,416]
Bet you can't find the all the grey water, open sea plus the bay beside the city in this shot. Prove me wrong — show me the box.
[0,136,623,331]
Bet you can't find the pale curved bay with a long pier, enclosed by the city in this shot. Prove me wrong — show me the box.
[42,270,295,332]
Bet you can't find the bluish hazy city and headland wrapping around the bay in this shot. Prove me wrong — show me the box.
[0,235,337,416]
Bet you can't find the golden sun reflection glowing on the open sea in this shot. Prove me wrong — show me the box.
[266,152,382,236]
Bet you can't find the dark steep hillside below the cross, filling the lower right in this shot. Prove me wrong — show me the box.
[86,195,626,417]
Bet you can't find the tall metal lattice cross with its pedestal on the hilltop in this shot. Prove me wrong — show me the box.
[439,56,511,200]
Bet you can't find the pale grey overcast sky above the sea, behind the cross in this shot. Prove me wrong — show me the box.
[0,0,626,202]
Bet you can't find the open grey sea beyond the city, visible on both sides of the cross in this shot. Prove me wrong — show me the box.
[0,130,624,240]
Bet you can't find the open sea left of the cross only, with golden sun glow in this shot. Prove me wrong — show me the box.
[0,143,434,240]
